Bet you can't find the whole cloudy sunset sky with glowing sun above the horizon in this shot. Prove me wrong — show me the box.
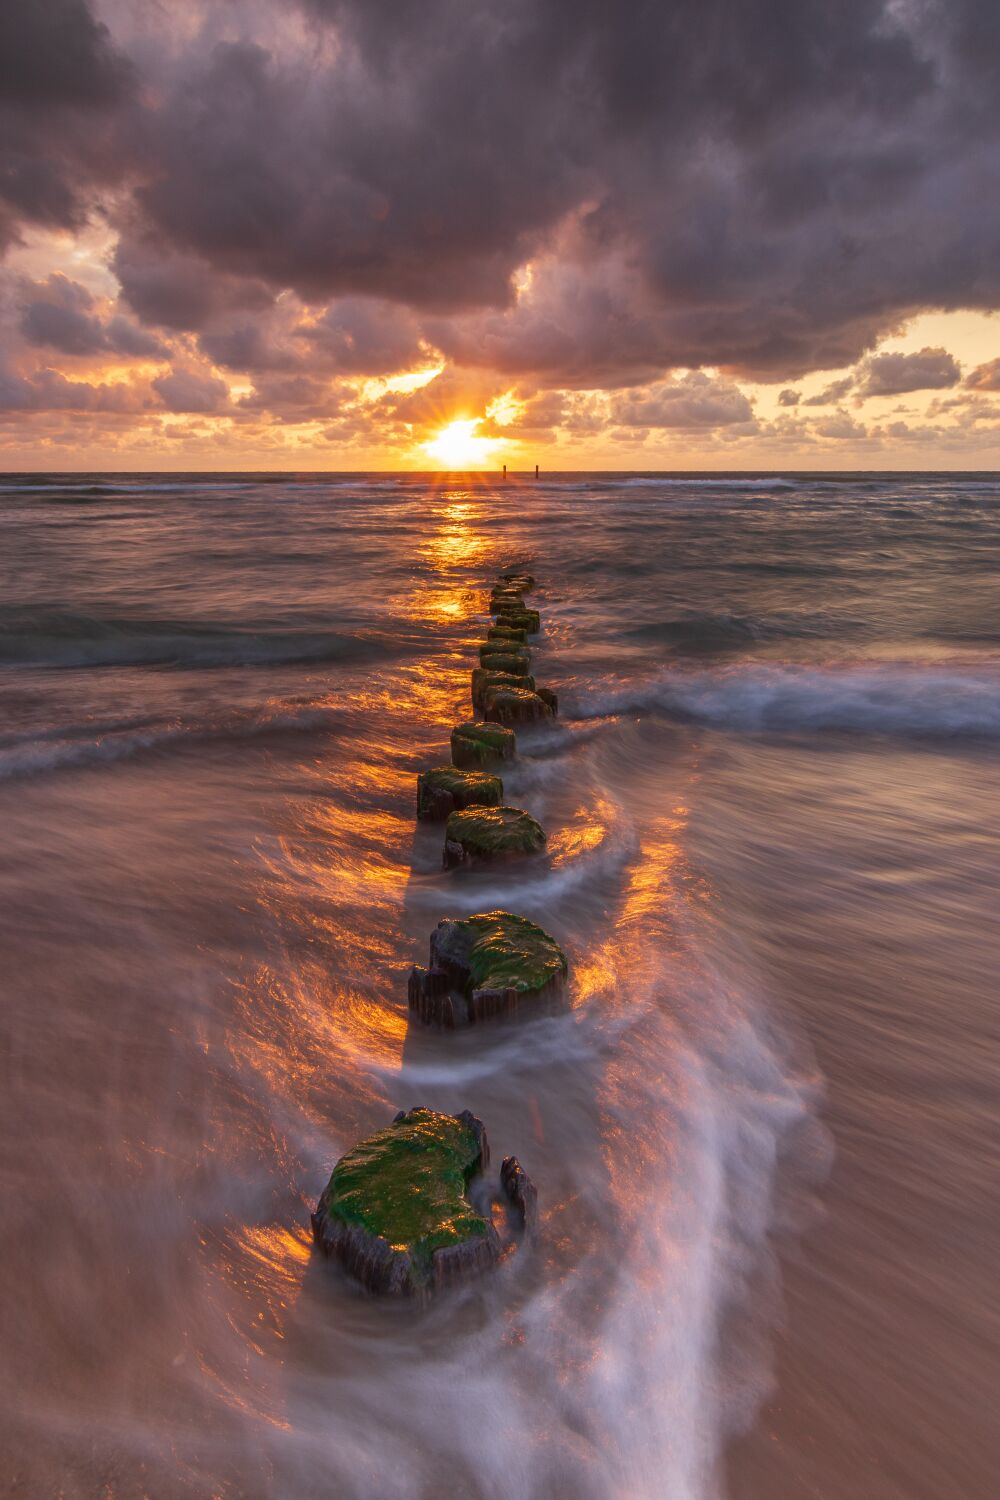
[0,0,1000,470]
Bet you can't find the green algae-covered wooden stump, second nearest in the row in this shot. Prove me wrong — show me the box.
[409,912,567,1026]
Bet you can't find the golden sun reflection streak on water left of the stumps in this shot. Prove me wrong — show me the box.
[229,486,515,1134]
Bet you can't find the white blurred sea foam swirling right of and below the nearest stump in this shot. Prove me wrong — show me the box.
[236,894,819,1500]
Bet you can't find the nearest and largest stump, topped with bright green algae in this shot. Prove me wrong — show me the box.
[312,1109,497,1293]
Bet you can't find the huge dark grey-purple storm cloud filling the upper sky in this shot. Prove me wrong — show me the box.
[0,0,1000,390]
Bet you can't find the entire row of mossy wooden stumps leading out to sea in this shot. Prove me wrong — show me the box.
[312,573,567,1293]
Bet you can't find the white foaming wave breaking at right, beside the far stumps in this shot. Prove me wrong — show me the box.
[577,663,1000,740]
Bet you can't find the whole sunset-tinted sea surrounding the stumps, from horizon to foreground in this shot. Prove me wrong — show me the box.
[0,474,1000,1500]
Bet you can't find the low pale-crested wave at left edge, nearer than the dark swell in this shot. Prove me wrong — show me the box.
[0,704,343,782]
